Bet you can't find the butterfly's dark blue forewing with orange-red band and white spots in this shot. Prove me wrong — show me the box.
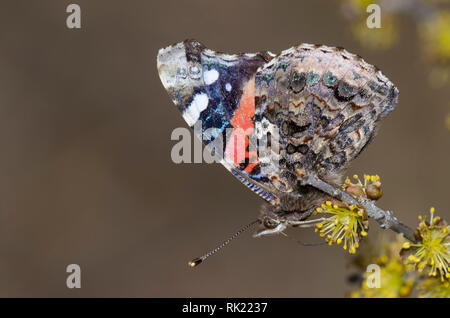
[158,40,277,203]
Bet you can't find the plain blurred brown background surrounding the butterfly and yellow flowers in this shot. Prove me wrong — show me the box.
[0,0,450,297]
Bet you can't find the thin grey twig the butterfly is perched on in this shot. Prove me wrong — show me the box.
[299,173,416,242]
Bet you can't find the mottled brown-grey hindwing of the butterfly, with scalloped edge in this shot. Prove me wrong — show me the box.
[255,44,398,191]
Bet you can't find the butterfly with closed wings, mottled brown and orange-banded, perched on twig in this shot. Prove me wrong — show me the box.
[158,40,398,234]
